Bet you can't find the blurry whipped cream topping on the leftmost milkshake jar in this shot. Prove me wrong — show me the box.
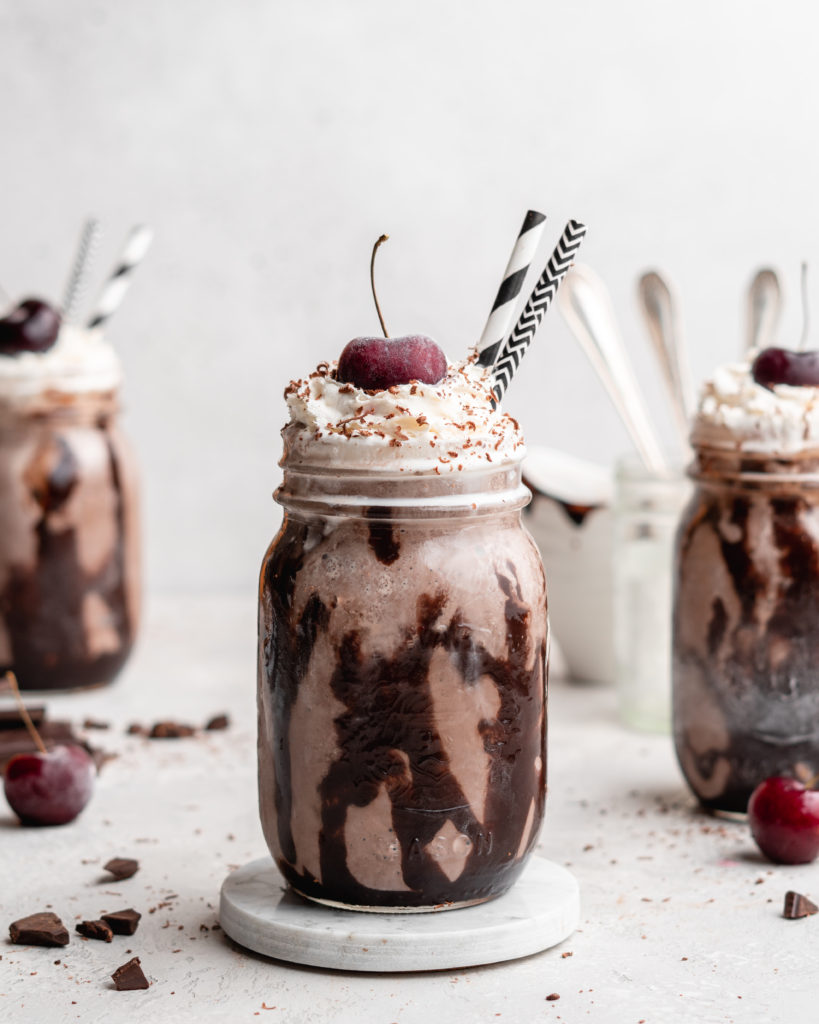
[0,325,122,398]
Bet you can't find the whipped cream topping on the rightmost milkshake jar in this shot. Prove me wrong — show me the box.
[691,362,819,455]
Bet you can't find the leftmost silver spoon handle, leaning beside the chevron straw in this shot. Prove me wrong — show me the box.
[557,263,667,473]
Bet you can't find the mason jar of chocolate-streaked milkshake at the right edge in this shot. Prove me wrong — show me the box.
[674,444,819,813]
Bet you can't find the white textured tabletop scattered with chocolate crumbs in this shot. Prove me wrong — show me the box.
[0,596,819,1024]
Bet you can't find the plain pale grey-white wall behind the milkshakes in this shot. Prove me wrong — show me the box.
[0,0,819,590]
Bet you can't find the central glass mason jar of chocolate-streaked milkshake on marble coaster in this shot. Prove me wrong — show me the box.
[258,456,549,911]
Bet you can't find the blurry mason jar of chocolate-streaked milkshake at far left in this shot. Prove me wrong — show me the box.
[0,381,140,690]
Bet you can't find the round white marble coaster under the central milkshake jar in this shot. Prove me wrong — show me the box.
[219,857,579,972]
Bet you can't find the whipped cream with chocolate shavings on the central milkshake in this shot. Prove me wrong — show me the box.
[282,356,525,474]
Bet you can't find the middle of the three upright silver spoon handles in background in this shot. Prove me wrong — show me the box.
[638,270,694,446]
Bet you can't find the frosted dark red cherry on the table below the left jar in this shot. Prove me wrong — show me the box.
[4,744,96,825]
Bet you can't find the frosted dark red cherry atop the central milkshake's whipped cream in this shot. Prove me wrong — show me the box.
[338,334,446,391]
